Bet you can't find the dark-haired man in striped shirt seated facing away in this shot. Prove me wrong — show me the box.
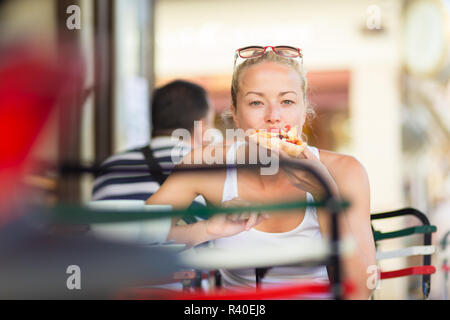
[92,80,214,210]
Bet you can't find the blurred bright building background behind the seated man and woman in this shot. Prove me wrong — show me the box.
[0,0,450,299]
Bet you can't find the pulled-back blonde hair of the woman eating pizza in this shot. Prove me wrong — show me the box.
[222,51,315,128]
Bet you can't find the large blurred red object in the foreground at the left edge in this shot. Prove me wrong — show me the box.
[0,44,84,225]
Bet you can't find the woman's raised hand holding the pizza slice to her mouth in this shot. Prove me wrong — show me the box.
[277,147,338,198]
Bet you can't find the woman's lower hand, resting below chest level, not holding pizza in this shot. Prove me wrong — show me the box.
[206,198,269,239]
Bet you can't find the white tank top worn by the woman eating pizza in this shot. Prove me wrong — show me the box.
[214,142,328,297]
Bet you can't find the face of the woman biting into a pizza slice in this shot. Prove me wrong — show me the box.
[233,62,306,132]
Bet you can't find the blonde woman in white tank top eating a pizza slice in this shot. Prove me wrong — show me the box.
[147,47,376,299]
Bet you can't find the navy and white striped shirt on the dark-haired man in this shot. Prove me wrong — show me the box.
[92,137,206,211]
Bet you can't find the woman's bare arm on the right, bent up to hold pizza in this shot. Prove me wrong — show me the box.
[282,148,376,299]
